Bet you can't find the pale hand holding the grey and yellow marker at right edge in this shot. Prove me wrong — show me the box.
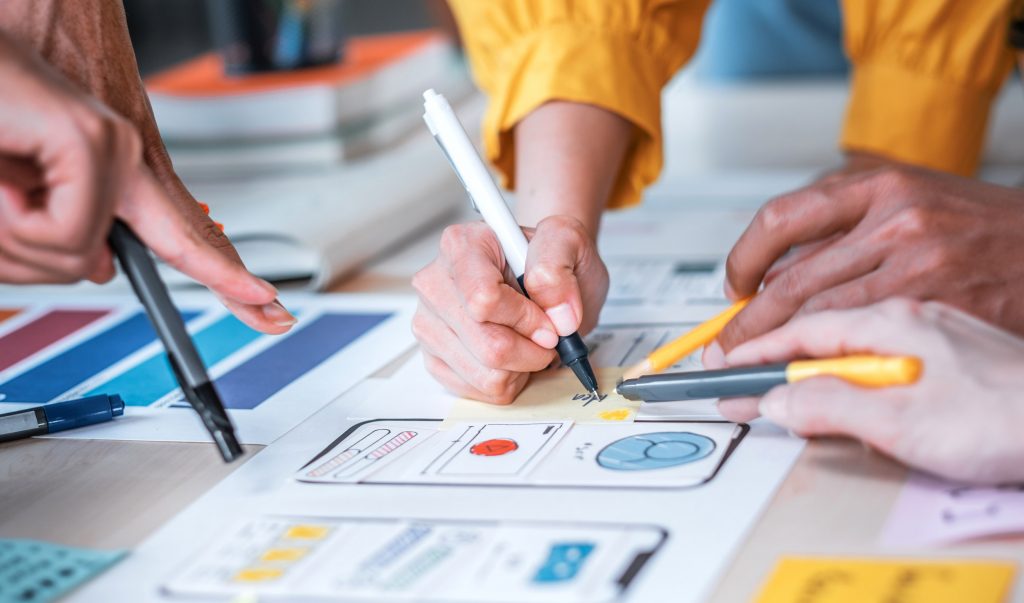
[719,299,1024,483]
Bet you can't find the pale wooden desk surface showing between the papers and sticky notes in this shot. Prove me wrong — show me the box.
[0,202,1024,602]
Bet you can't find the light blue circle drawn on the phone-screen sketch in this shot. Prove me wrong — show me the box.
[597,431,715,471]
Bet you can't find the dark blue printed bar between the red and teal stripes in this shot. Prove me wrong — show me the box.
[0,312,199,402]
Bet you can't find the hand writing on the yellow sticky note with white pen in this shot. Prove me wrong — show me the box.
[413,216,608,404]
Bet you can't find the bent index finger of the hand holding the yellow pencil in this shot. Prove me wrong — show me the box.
[725,178,870,299]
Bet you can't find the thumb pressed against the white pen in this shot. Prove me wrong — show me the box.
[523,216,596,337]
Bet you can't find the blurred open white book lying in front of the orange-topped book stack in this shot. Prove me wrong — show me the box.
[174,96,484,290]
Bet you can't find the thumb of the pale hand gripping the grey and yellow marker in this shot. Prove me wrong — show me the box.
[758,377,902,450]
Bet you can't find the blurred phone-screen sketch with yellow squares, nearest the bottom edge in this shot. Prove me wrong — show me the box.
[161,516,665,603]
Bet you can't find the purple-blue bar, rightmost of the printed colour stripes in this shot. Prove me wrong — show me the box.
[215,313,391,408]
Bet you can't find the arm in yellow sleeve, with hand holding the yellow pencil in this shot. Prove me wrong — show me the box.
[708,0,1020,352]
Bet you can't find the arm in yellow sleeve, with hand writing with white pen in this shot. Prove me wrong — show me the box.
[413,0,707,403]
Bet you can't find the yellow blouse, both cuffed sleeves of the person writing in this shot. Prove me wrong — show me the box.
[450,0,1013,207]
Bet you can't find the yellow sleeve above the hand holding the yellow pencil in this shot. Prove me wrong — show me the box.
[841,0,1013,175]
